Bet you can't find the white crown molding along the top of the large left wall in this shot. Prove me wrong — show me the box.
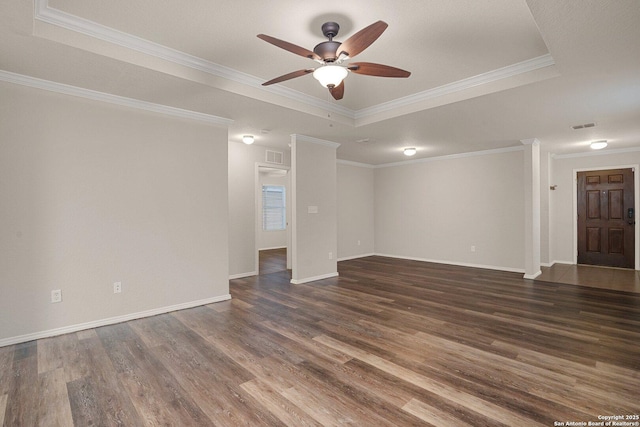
[0,70,233,126]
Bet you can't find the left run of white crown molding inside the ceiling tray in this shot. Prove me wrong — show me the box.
[34,0,355,120]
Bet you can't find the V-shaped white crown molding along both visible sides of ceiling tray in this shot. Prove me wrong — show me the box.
[34,0,555,126]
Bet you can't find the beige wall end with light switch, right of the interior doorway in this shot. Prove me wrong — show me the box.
[291,135,338,283]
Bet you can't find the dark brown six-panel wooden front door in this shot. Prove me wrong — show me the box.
[578,169,635,268]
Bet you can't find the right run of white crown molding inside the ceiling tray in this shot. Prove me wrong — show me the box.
[355,54,556,120]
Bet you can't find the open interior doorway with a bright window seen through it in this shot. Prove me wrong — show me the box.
[255,163,291,275]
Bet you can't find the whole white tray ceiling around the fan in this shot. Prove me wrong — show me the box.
[0,0,640,165]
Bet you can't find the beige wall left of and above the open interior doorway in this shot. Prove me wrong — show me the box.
[229,142,291,277]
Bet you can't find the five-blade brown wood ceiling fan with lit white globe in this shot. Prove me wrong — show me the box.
[258,21,411,100]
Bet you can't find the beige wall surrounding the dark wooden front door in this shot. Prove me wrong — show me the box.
[549,150,640,264]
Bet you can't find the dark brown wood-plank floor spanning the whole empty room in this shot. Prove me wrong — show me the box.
[0,257,640,427]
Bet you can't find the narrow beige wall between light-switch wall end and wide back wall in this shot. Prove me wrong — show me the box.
[337,161,375,260]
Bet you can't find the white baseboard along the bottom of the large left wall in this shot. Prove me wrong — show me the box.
[0,294,231,347]
